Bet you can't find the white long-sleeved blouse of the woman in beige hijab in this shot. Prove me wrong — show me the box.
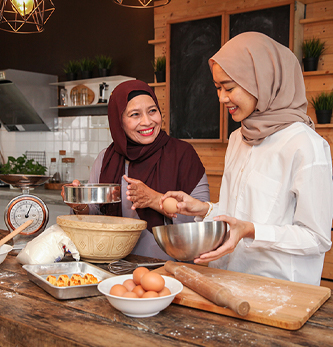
[206,123,333,285]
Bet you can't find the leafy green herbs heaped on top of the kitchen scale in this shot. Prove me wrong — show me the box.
[0,154,47,175]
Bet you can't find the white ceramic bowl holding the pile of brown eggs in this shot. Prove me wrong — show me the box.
[97,275,183,318]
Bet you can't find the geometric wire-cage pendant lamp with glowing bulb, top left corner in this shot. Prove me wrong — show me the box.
[0,0,55,34]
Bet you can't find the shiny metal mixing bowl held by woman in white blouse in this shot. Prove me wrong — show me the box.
[153,221,227,261]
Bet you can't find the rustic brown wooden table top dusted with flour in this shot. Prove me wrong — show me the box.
[0,231,333,347]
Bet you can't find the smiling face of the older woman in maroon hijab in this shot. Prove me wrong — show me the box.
[122,94,162,145]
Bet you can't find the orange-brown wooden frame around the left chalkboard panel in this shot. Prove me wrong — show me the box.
[166,11,225,143]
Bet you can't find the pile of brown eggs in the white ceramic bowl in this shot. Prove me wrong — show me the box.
[110,267,171,298]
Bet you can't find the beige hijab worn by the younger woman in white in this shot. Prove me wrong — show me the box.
[209,32,314,145]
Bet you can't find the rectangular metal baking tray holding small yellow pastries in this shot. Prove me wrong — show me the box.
[23,261,114,300]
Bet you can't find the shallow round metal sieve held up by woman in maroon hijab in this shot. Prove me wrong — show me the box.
[64,183,121,204]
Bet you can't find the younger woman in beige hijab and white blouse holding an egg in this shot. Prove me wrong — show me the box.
[161,32,333,285]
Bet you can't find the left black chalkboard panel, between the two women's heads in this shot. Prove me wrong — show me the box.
[170,16,222,139]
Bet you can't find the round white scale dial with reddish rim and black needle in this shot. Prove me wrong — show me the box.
[5,194,49,235]
